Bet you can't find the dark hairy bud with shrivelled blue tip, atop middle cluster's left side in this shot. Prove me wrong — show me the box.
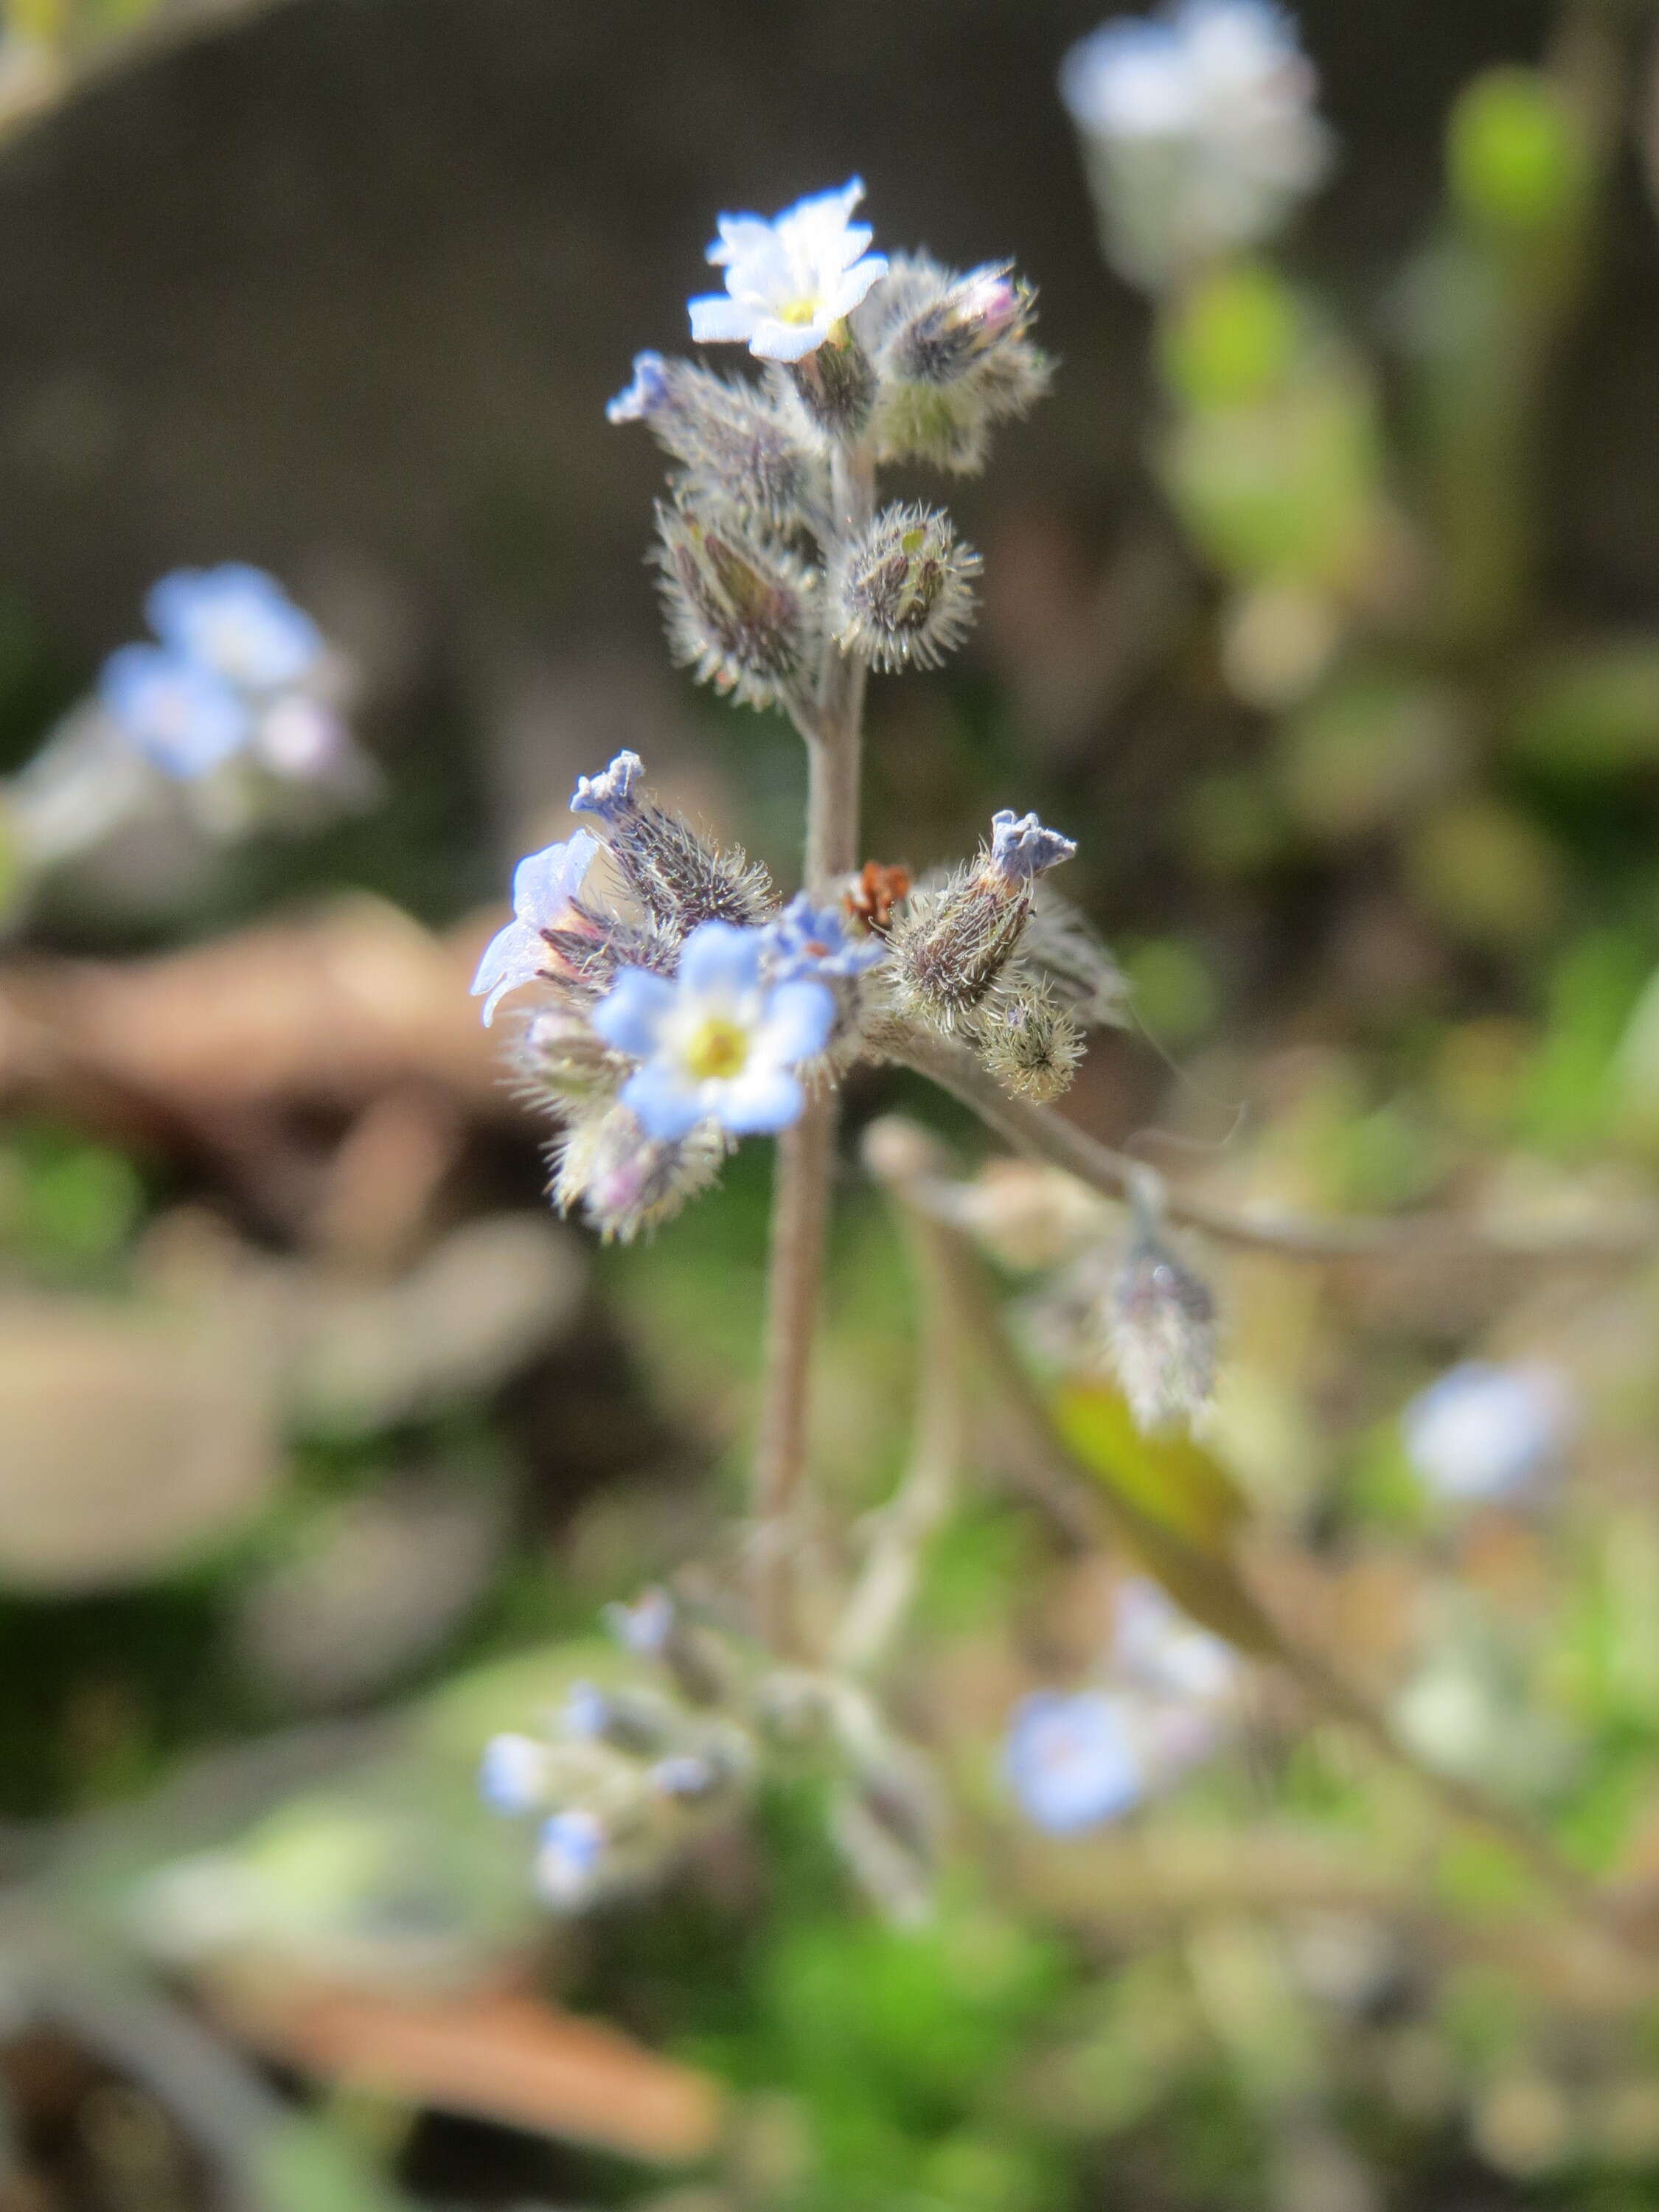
[557,752,772,929]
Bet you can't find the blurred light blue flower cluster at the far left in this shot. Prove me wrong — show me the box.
[97,562,361,783]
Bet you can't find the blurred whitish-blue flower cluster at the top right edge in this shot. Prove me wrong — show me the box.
[1060,0,1332,292]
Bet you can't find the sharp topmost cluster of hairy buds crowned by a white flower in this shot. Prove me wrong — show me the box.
[606,177,1046,721]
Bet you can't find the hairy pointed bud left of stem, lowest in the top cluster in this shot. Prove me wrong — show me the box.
[657,495,818,708]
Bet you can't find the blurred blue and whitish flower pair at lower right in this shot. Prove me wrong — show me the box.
[1002,1579,1239,1836]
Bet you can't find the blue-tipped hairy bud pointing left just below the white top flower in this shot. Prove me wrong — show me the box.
[606,354,827,531]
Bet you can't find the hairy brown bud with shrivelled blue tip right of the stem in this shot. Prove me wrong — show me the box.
[885,807,1077,1031]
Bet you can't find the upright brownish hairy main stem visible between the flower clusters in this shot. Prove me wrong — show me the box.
[754,447,876,1650]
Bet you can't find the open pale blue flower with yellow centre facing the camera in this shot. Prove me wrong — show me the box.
[593,922,836,1144]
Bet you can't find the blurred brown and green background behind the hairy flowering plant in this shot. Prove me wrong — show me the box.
[16,0,1659,2212]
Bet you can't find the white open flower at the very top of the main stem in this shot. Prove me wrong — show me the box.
[690,177,887,361]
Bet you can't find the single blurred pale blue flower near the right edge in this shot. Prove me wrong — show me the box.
[1400,1360,1575,1504]
